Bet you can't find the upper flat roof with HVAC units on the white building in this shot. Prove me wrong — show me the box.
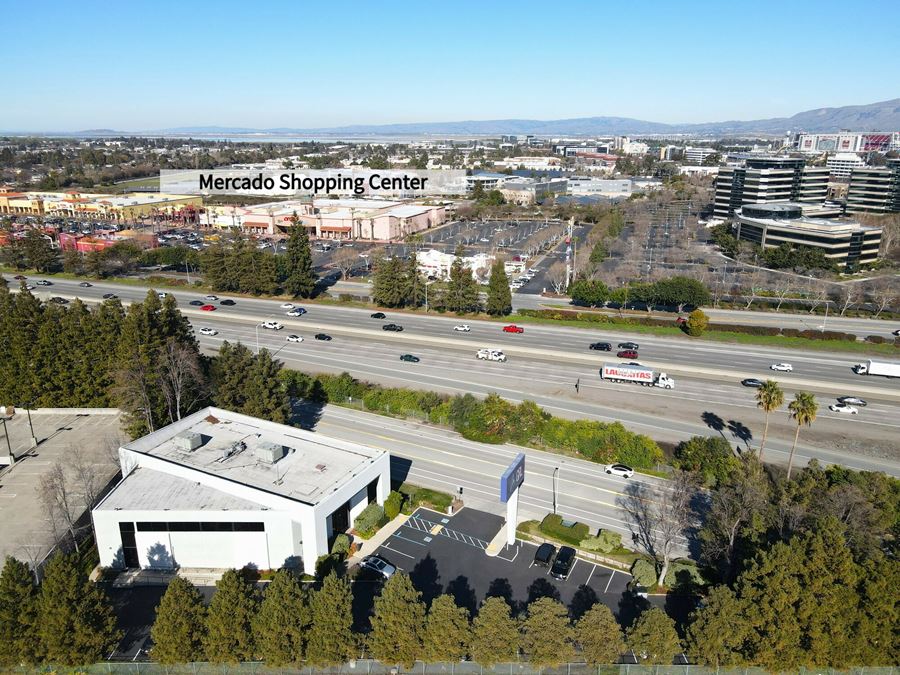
[123,407,386,504]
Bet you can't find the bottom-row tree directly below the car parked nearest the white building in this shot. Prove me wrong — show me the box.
[369,573,425,668]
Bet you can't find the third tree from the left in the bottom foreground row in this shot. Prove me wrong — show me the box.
[150,576,206,665]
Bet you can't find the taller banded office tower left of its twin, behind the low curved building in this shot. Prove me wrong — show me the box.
[713,157,828,218]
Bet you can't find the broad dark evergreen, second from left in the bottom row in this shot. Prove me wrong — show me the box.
[37,553,122,666]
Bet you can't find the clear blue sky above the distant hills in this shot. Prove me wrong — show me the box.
[0,0,900,131]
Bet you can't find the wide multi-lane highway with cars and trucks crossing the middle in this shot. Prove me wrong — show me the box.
[12,280,900,475]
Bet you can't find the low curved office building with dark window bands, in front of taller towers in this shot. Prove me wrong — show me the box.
[733,203,881,266]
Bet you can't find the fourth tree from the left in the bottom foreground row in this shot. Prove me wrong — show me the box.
[203,570,259,663]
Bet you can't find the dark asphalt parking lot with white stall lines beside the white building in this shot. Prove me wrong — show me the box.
[366,508,641,618]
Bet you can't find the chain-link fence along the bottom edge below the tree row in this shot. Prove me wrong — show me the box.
[12,660,900,675]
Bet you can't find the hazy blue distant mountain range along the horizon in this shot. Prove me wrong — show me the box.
[8,98,900,138]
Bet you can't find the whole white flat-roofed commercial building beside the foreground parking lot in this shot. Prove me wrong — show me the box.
[92,407,390,574]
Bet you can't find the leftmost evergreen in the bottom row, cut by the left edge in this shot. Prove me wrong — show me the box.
[0,557,40,668]
